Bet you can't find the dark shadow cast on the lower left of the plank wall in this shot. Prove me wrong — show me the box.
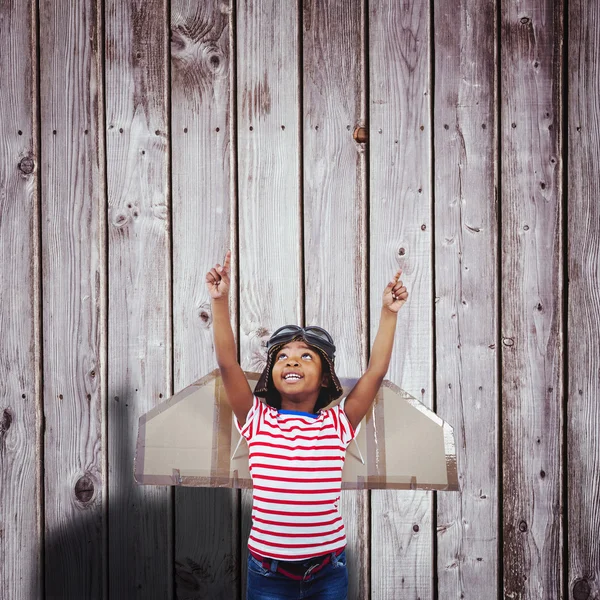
[34,392,237,600]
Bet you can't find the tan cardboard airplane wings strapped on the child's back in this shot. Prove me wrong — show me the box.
[134,369,458,491]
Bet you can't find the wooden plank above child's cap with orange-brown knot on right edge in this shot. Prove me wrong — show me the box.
[303,0,370,598]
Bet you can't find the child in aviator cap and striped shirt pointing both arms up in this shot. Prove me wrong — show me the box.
[206,252,408,600]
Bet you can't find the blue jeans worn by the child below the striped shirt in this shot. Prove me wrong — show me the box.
[246,550,348,600]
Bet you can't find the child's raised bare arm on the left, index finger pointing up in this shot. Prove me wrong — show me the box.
[206,250,253,425]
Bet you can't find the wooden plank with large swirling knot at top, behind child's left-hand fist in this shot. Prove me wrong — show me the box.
[171,0,239,600]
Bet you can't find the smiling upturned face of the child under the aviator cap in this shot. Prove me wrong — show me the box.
[272,340,323,398]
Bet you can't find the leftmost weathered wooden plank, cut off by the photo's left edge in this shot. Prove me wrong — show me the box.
[0,2,43,600]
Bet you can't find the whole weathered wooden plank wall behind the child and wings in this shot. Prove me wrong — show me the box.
[0,0,600,600]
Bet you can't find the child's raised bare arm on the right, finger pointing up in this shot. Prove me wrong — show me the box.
[344,271,408,429]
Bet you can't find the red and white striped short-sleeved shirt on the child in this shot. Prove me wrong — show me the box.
[235,396,360,560]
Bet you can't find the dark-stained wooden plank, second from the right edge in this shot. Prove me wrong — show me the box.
[500,0,563,598]
